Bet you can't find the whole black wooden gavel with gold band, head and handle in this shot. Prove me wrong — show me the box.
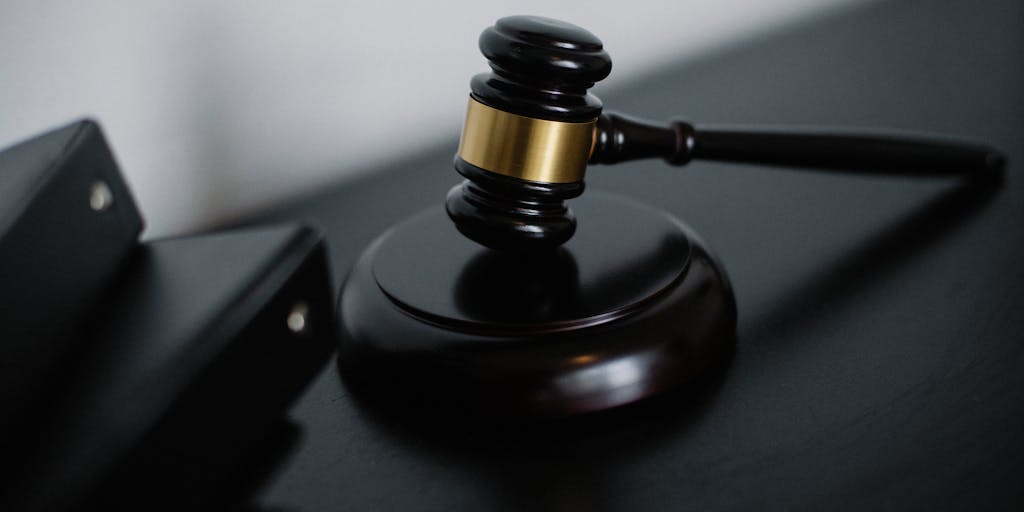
[446,16,1006,252]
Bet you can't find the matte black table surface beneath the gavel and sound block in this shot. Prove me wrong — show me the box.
[245,0,1024,511]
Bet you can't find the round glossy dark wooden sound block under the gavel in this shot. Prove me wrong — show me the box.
[338,193,736,415]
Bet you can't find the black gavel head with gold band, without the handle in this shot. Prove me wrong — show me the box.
[445,16,611,252]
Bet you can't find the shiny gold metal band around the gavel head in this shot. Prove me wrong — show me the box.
[459,97,597,183]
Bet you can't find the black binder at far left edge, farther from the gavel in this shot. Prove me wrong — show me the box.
[0,120,142,448]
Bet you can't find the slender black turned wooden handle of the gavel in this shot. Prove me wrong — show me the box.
[590,112,1006,176]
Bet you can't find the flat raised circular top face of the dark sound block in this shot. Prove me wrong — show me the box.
[380,193,690,334]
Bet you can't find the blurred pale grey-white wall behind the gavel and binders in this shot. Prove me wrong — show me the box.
[0,0,857,238]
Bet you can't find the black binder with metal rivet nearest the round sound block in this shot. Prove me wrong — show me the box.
[13,225,335,510]
